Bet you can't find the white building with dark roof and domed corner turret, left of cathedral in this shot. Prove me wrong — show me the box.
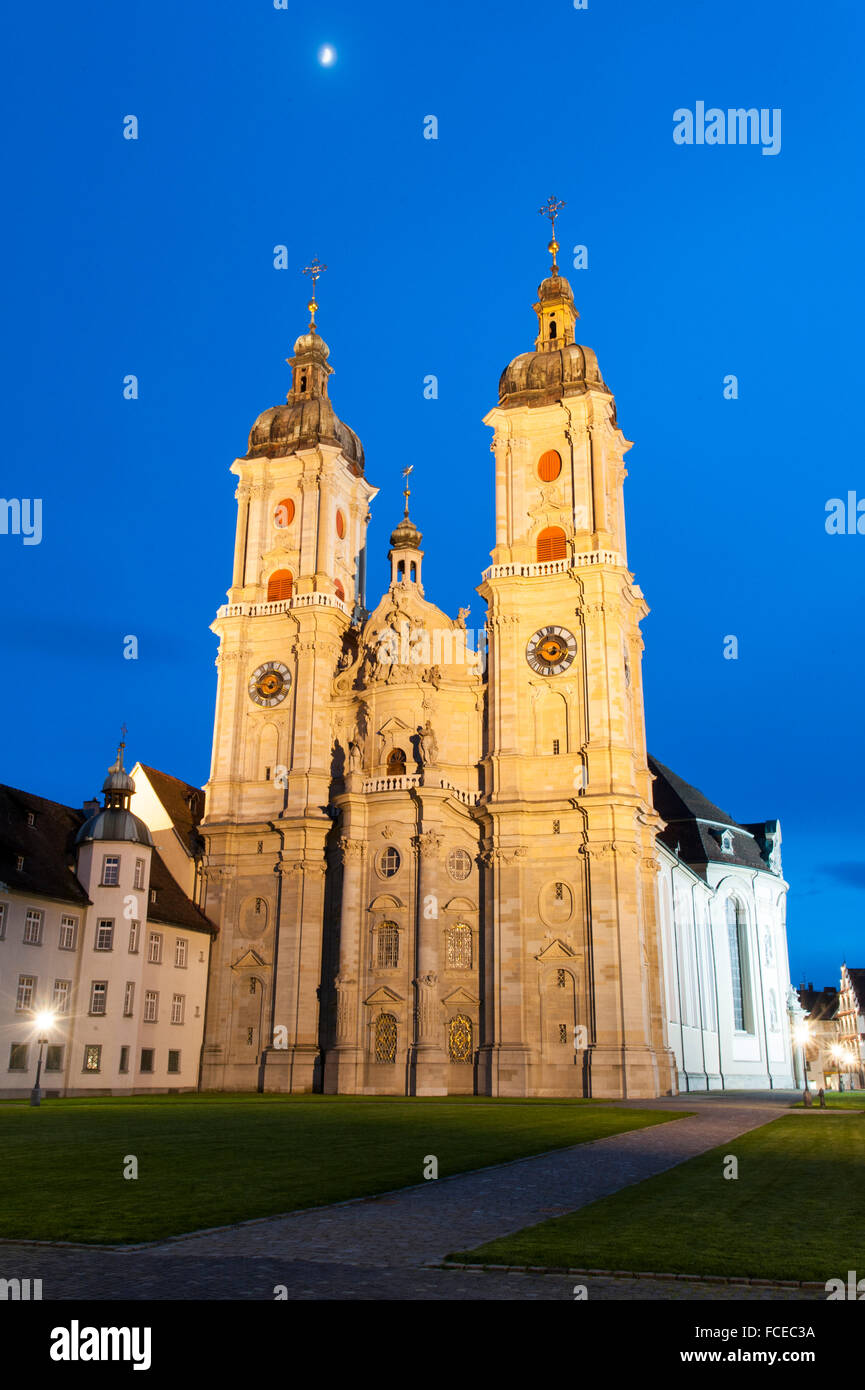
[0,745,216,1097]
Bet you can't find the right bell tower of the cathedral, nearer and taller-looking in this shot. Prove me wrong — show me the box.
[478,199,673,1097]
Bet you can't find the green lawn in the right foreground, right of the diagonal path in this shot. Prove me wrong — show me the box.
[451,1115,865,1280]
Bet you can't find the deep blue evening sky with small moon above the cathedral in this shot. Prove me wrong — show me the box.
[0,0,865,984]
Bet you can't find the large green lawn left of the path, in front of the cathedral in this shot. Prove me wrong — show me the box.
[0,1095,676,1244]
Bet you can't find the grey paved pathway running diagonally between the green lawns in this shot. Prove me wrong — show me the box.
[0,1093,825,1300]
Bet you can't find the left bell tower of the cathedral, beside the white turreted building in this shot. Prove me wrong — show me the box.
[202,268,377,1091]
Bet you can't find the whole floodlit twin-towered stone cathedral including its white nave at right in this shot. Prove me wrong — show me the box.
[199,219,797,1097]
